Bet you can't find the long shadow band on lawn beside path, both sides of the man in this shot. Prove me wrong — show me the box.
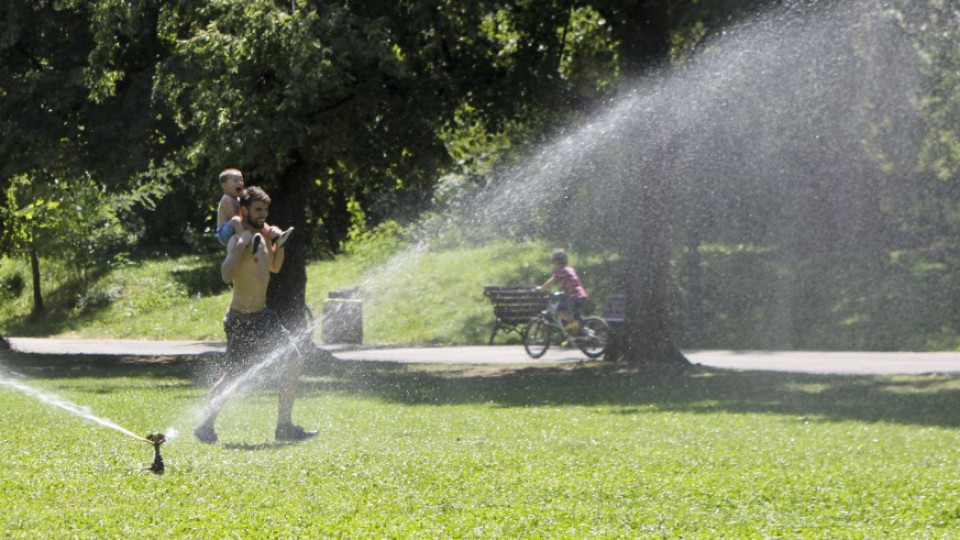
[7,353,960,430]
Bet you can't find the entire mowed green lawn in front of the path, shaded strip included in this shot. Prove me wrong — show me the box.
[0,355,960,538]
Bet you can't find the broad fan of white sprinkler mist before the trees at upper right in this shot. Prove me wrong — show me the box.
[465,2,920,247]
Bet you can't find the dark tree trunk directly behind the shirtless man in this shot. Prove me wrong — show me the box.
[267,156,312,337]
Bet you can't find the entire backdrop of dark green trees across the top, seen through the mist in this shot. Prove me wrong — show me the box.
[0,0,960,358]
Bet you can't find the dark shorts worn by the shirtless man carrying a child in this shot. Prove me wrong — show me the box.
[223,308,296,373]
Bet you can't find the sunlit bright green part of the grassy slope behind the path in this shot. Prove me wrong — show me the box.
[0,243,549,344]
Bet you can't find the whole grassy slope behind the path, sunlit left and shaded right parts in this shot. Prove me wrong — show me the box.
[0,238,960,351]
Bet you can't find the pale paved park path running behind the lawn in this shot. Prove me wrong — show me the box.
[8,338,960,375]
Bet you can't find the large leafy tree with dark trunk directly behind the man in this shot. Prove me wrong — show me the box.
[147,0,454,329]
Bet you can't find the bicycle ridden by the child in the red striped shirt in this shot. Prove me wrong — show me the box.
[523,293,610,358]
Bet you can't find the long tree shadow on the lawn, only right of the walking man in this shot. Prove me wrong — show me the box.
[305,362,960,428]
